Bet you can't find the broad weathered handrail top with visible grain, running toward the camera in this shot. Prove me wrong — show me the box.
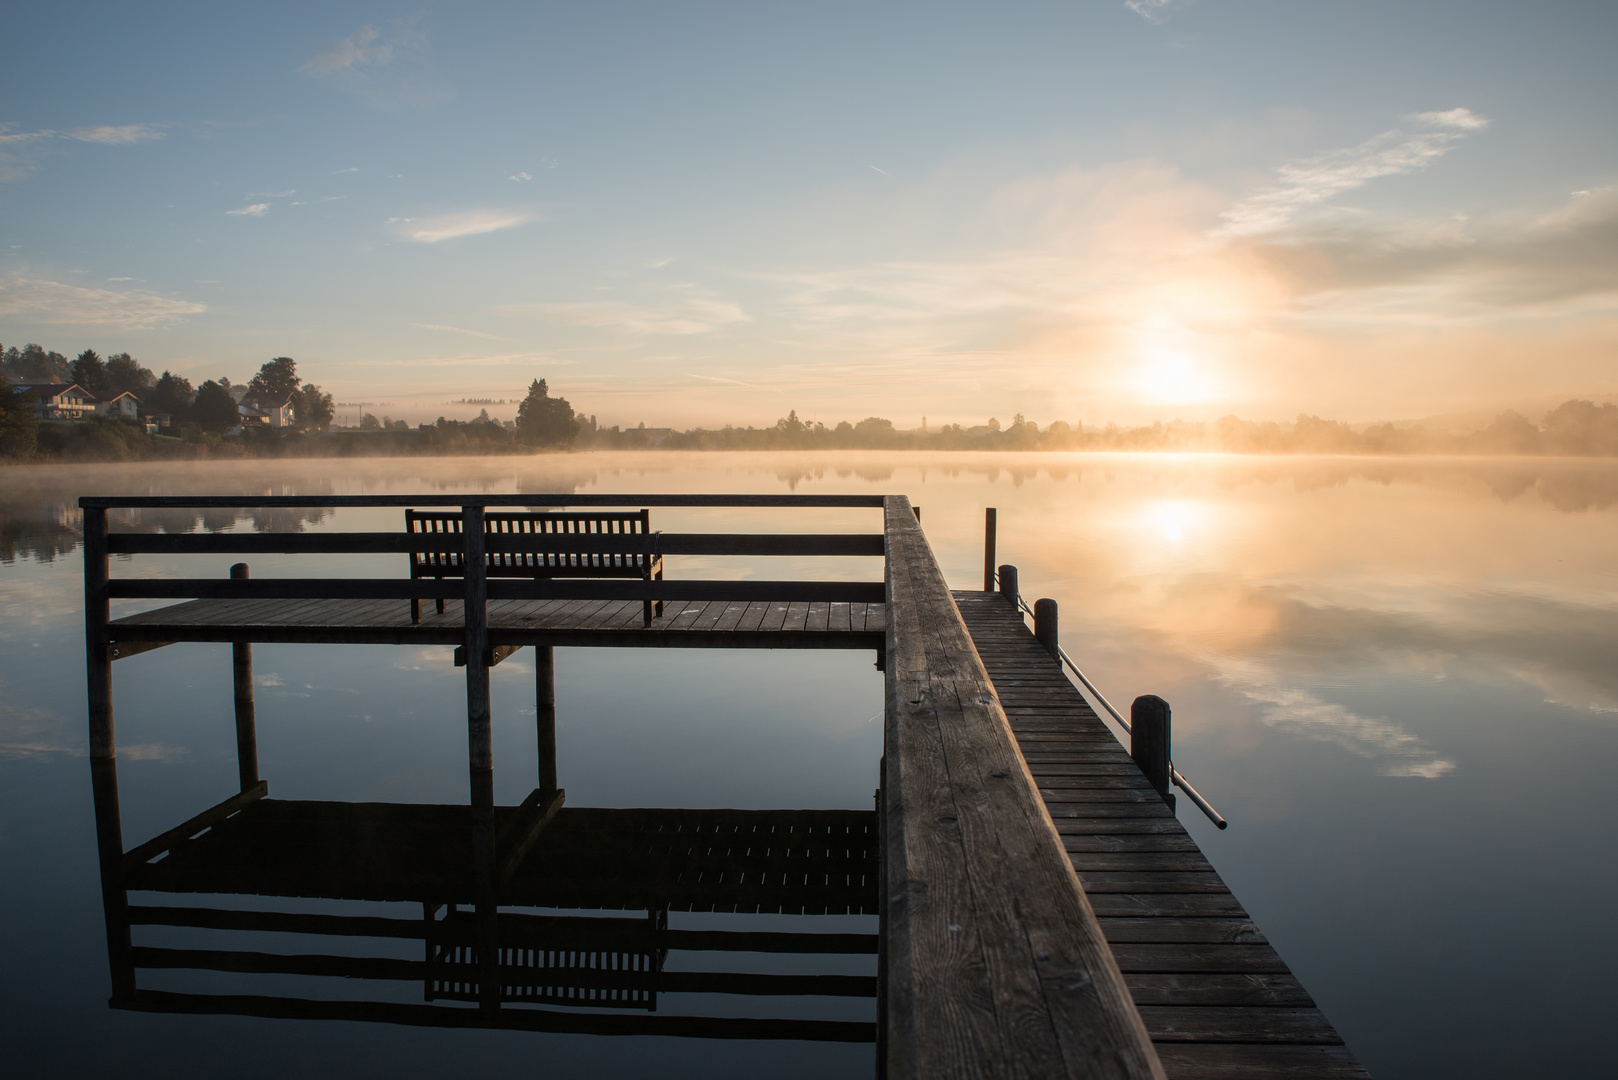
[882,497,1163,1078]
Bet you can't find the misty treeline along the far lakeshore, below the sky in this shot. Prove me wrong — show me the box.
[0,345,1618,461]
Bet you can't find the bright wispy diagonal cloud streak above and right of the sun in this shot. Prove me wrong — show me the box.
[1215,108,1489,236]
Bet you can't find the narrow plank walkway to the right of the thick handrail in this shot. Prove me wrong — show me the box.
[953,591,1369,1080]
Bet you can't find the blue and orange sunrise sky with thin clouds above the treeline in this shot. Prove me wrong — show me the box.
[0,0,1618,427]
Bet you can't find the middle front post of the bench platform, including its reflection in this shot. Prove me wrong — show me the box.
[461,505,500,1009]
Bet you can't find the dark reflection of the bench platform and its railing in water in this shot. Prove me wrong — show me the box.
[102,777,877,1043]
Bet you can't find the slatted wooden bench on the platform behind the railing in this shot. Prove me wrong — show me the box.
[405,510,663,627]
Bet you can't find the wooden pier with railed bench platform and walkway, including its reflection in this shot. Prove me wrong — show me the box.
[81,494,1364,1080]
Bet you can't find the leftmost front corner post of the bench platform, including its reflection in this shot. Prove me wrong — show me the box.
[84,507,134,997]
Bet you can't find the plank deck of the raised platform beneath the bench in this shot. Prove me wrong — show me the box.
[108,597,887,649]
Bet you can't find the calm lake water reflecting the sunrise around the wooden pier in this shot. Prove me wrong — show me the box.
[0,453,1618,1078]
